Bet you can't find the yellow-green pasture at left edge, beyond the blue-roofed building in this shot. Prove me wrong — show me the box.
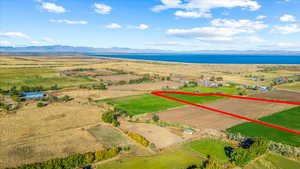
[0,68,92,89]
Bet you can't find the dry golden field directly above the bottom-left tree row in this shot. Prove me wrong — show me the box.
[0,128,103,168]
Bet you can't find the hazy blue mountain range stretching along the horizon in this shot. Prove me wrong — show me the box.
[0,45,300,56]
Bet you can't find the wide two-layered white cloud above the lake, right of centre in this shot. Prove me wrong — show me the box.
[166,19,268,44]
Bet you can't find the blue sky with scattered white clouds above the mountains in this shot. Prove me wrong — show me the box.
[0,0,300,51]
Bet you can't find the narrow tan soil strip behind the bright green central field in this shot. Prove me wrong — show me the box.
[109,81,182,91]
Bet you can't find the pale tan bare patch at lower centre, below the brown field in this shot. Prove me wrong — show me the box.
[120,121,183,148]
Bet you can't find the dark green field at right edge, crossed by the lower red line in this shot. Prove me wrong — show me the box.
[227,107,300,147]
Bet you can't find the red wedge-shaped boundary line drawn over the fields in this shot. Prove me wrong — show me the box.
[151,91,300,135]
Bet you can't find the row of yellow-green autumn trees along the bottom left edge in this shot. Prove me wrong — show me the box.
[7,147,121,169]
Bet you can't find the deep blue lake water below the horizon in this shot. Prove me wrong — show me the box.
[93,54,300,64]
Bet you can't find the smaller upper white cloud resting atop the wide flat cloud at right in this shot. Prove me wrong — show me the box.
[211,19,268,32]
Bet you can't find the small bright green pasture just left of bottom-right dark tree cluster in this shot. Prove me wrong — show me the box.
[185,139,231,162]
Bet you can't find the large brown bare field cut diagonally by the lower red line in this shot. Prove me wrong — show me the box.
[158,96,293,130]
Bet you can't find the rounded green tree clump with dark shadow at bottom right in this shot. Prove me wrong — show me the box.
[225,138,269,166]
